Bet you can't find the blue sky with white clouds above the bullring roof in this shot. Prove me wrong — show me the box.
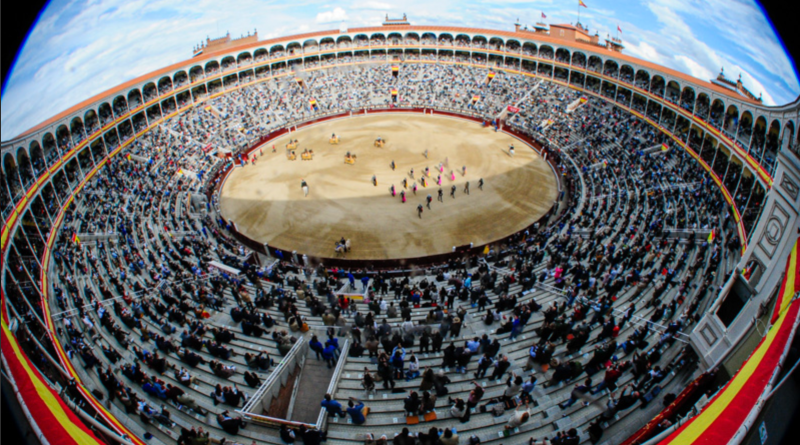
[0,0,800,140]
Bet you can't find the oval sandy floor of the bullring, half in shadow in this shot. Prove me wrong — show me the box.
[220,113,558,260]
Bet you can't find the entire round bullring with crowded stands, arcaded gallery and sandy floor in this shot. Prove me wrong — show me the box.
[0,12,800,445]
